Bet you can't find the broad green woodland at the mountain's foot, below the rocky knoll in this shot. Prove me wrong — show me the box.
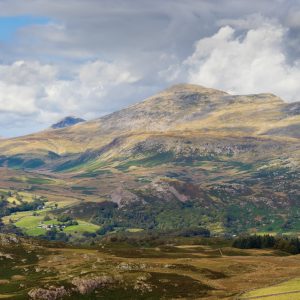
[87,199,213,232]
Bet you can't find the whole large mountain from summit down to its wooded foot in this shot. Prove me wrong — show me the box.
[0,84,300,233]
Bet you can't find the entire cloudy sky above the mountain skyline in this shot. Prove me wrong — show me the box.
[0,0,300,137]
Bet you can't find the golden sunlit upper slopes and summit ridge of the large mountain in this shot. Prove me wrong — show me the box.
[0,84,300,162]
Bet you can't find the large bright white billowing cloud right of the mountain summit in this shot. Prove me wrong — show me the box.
[168,20,300,101]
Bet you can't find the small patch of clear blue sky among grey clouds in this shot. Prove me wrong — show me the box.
[0,16,49,42]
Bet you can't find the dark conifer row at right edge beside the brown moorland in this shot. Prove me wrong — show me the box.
[232,235,300,254]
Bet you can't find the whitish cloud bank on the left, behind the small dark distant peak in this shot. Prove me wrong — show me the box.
[0,60,139,135]
